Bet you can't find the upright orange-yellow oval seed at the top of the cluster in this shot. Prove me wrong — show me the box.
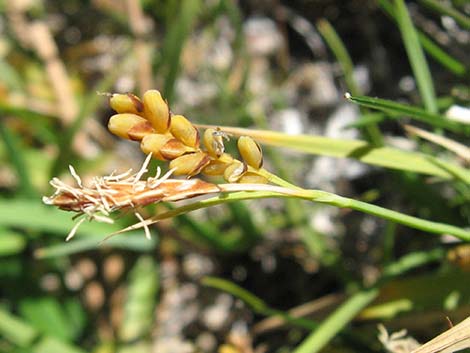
[143,89,171,133]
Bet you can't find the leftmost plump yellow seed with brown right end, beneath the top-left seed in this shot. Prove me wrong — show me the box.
[108,113,154,140]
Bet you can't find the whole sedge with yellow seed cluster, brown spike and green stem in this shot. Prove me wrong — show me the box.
[43,90,470,241]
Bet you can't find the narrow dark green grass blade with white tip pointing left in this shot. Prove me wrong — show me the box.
[346,95,470,135]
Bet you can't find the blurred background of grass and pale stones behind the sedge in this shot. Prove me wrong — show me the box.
[0,0,470,353]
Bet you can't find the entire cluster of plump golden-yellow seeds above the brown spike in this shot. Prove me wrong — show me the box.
[108,90,268,184]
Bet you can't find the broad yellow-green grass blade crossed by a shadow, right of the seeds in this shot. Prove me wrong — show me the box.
[199,124,470,183]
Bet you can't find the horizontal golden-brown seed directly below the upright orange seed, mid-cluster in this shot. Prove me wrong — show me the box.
[140,134,193,161]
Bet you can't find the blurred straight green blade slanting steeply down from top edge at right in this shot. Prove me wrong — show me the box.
[395,0,437,113]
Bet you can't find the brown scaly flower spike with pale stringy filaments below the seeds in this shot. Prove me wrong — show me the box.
[43,154,220,240]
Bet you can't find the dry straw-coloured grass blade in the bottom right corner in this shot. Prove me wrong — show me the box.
[411,317,470,353]
